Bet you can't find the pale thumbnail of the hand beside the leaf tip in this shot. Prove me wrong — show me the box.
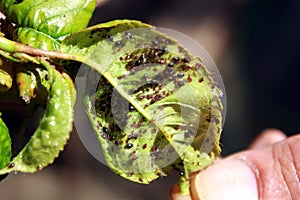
[191,159,258,200]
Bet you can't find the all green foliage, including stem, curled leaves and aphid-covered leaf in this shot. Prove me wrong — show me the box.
[0,0,222,194]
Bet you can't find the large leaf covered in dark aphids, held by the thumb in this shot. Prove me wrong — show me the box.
[69,21,222,193]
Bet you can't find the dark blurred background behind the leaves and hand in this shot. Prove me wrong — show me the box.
[0,0,300,200]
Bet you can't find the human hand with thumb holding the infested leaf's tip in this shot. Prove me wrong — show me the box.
[171,129,300,200]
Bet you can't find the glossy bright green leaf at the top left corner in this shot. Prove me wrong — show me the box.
[0,0,96,38]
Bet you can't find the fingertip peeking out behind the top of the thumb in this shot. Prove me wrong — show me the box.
[249,129,286,149]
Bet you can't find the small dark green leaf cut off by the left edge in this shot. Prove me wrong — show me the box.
[0,113,12,169]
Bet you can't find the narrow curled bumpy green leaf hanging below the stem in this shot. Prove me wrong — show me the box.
[0,61,75,174]
